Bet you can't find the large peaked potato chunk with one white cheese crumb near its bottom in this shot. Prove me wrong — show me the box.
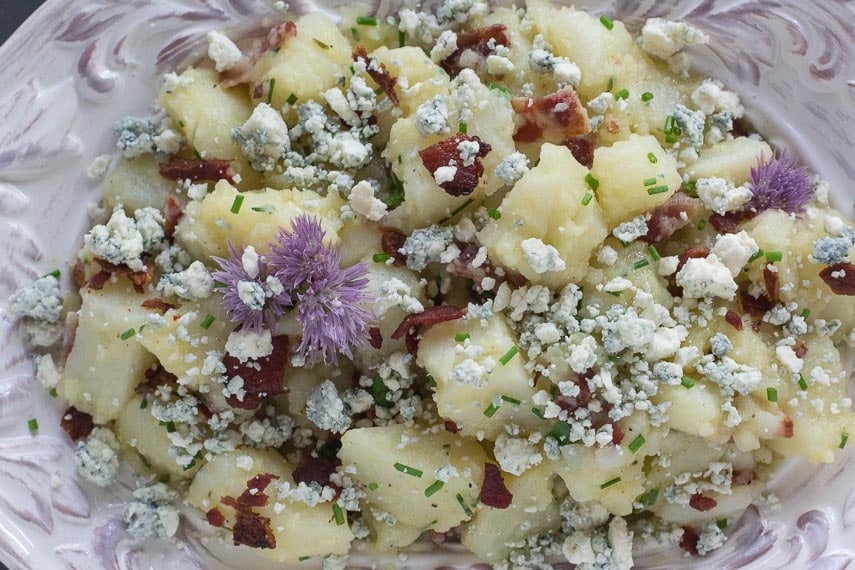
[478,144,607,289]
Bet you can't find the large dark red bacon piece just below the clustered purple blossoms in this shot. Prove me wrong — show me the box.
[223,335,288,410]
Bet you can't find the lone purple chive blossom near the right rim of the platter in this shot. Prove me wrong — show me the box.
[745,150,813,214]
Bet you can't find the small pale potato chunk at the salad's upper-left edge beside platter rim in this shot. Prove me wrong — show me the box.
[104,154,175,215]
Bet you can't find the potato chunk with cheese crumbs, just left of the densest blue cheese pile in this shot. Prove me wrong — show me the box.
[418,314,543,440]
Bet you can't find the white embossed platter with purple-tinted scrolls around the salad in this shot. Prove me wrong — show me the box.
[0,0,855,570]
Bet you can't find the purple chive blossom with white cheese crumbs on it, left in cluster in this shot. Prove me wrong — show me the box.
[212,242,293,333]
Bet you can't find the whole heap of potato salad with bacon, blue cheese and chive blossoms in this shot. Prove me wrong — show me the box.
[8,0,855,569]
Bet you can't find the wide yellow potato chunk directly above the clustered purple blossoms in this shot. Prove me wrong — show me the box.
[176,180,344,259]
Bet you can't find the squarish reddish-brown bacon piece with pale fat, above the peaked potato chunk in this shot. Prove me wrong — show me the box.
[511,87,591,144]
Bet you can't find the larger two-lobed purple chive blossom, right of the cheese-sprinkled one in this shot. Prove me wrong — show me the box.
[270,215,371,366]
